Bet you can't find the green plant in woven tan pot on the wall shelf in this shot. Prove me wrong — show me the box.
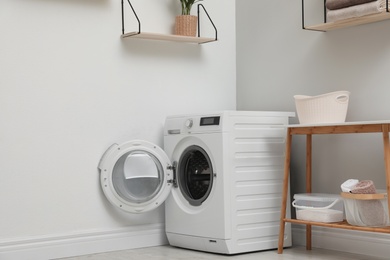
[175,0,202,36]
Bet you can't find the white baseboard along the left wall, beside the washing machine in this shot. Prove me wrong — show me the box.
[0,224,168,260]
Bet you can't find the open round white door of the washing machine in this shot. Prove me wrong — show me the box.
[99,140,173,213]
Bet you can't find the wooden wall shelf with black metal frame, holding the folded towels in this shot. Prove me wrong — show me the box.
[302,0,390,32]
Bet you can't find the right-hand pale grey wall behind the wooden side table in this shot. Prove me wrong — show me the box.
[236,0,390,256]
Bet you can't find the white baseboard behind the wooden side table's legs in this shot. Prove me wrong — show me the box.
[292,225,390,259]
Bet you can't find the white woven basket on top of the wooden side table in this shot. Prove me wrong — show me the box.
[294,91,350,124]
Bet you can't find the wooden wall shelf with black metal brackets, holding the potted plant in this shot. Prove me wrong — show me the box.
[121,0,217,44]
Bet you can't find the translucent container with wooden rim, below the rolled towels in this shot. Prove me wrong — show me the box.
[341,192,390,227]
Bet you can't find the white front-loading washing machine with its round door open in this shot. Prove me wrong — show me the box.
[99,111,295,255]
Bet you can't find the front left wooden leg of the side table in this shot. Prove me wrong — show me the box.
[278,128,292,254]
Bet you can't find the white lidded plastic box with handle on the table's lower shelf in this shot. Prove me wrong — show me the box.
[292,193,344,223]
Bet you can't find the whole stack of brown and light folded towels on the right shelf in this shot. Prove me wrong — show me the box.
[326,0,390,22]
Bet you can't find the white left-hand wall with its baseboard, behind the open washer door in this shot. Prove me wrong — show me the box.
[0,0,236,259]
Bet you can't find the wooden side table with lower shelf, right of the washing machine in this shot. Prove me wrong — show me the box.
[278,120,390,254]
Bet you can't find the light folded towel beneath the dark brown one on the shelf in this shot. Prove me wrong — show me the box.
[326,0,390,22]
